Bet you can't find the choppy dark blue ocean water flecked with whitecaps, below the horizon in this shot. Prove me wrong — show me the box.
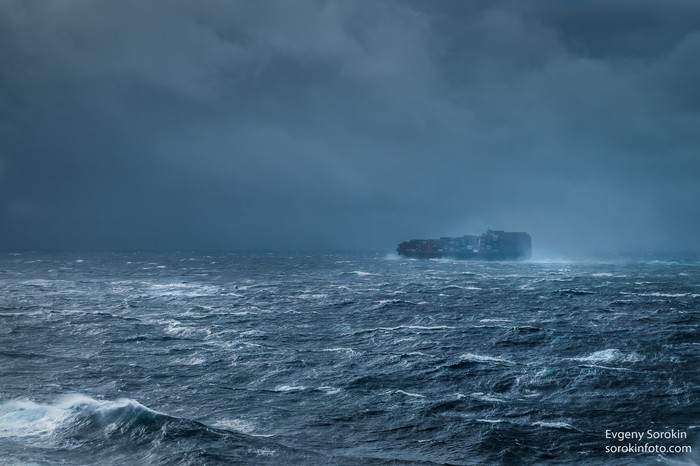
[0,252,700,465]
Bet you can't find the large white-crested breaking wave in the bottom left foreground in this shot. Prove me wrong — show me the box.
[0,394,313,464]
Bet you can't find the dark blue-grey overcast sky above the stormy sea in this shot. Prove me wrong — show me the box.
[0,0,700,254]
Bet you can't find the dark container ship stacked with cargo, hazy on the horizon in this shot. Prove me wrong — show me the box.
[396,230,532,260]
